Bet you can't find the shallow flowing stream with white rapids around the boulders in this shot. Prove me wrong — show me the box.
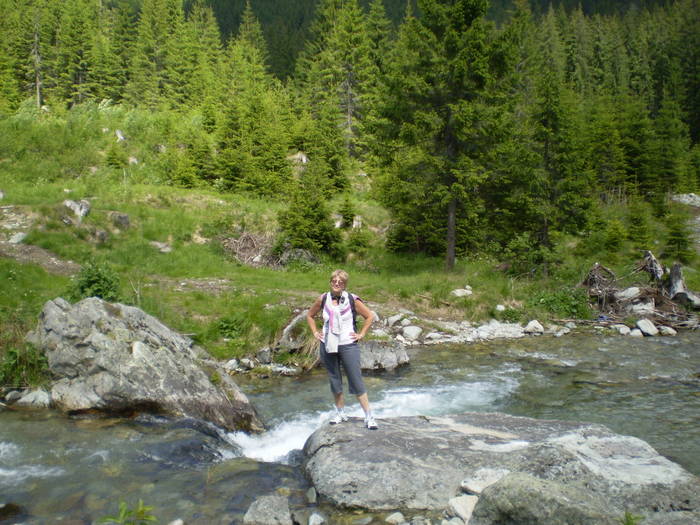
[0,332,700,525]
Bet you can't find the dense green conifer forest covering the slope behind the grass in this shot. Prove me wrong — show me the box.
[0,0,700,268]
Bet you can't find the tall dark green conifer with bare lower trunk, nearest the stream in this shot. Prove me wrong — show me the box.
[378,0,502,269]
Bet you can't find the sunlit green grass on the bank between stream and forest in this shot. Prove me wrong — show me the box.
[0,105,700,374]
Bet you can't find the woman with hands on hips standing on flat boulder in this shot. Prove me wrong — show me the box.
[306,270,377,430]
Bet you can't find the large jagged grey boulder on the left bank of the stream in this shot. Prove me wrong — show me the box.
[27,297,263,431]
